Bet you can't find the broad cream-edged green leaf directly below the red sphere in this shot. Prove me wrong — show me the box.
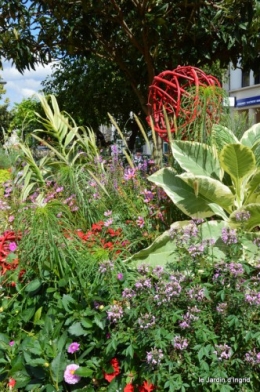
[171,140,223,179]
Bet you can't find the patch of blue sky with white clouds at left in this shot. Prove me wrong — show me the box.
[0,61,51,109]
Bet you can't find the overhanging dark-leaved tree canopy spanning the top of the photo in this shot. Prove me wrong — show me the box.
[0,0,260,112]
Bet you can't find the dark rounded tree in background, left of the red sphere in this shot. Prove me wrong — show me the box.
[42,57,140,129]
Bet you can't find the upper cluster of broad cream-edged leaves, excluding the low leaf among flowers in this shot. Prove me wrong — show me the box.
[149,124,260,231]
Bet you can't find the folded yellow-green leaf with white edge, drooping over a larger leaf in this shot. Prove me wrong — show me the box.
[178,173,235,213]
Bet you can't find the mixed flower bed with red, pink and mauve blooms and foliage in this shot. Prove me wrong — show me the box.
[0,93,260,392]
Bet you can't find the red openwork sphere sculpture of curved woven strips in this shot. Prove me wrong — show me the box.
[147,66,222,141]
